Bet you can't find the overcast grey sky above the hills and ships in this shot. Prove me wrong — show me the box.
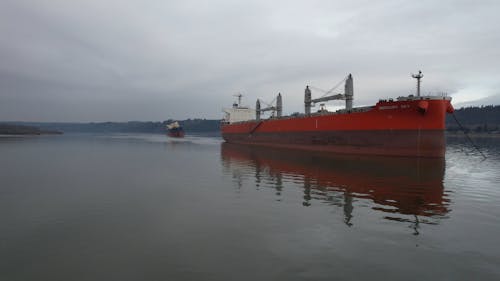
[0,0,500,122]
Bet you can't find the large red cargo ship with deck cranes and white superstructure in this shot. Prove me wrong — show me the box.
[221,72,454,157]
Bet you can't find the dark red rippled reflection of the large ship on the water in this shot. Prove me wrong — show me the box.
[221,143,449,229]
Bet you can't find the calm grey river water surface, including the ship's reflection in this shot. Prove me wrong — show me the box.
[0,135,500,281]
